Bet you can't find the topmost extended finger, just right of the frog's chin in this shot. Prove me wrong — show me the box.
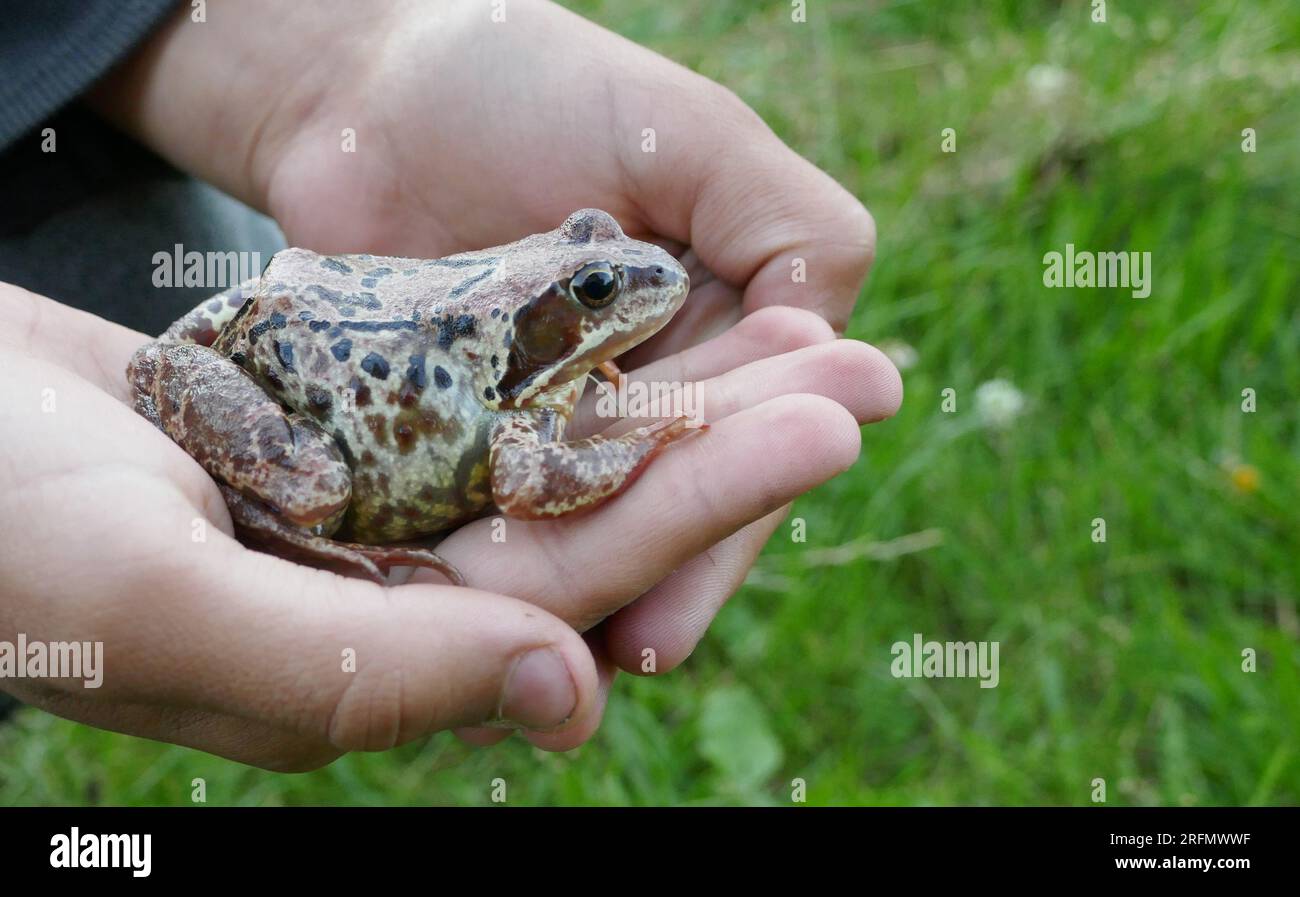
[571,306,835,437]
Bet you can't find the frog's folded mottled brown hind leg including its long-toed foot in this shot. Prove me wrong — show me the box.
[127,342,463,584]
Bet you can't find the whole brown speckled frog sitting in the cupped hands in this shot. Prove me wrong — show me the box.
[126,209,707,585]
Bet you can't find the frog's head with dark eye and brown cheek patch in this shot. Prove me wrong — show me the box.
[495,209,690,407]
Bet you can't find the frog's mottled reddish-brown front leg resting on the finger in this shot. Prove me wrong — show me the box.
[491,411,703,520]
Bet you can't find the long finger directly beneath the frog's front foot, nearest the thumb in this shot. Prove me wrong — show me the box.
[439,394,861,629]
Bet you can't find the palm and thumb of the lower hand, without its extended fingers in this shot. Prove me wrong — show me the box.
[0,285,601,770]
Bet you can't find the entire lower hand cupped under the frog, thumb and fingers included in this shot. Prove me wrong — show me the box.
[0,286,897,768]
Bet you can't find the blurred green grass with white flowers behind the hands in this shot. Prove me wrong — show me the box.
[0,0,1300,805]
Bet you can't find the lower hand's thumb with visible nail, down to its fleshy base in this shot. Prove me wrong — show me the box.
[90,536,597,750]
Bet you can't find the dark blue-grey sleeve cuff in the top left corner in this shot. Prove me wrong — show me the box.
[0,0,177,150]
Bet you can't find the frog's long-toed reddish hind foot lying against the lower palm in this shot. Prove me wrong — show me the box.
[218,484,465,585]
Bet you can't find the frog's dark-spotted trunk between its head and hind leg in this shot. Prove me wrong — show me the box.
[215,250,491,542]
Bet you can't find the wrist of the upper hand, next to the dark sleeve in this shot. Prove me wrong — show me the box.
[86,0,397,211]
